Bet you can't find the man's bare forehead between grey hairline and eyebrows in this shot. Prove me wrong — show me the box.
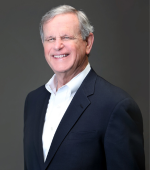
[43,13,79,36]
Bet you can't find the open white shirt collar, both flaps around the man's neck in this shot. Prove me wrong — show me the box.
[45,63,91,94]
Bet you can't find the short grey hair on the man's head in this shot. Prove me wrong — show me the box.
[40,5,94,41]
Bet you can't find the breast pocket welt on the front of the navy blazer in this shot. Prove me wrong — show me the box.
[68,131,98,140]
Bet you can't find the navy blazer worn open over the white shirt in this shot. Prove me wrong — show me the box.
[24,69,145,170]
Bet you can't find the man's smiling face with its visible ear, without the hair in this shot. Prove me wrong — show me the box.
[43,14,94,76]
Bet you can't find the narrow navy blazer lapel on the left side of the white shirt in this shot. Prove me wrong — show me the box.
[34,87,50,169]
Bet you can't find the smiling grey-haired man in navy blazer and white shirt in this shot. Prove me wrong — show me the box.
[24,5,145,170]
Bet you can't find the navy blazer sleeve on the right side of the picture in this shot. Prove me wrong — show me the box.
[104,98,145,170]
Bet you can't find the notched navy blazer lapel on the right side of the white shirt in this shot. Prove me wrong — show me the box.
[44,70,97,169]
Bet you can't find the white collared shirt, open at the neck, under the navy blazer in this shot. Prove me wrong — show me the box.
[42,63,91,161]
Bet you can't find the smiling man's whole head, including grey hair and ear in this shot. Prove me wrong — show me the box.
[41,5,94,79]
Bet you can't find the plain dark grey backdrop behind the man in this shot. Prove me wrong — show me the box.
[0,0,149,170]
